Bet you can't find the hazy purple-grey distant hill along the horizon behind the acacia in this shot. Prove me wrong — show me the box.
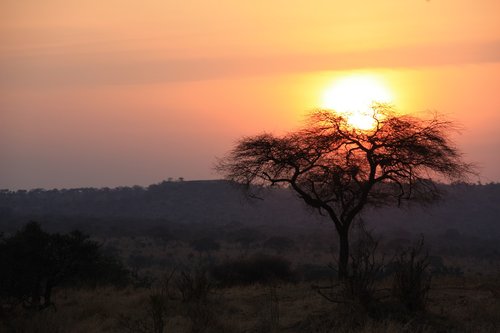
[0,180,500,239]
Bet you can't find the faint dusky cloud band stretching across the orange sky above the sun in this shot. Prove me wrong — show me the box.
[0,40,500,87]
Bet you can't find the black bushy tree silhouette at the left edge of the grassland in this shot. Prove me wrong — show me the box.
[0,222,128,309]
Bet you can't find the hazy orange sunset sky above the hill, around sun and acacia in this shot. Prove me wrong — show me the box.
[0,0,500,189]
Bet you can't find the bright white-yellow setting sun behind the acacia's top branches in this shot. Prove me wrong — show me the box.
[321,74,393,130]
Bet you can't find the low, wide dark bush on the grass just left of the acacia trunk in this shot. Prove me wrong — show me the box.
[212,255,294,286]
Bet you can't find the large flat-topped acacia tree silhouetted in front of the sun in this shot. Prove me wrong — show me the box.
[216,104,472,278]
